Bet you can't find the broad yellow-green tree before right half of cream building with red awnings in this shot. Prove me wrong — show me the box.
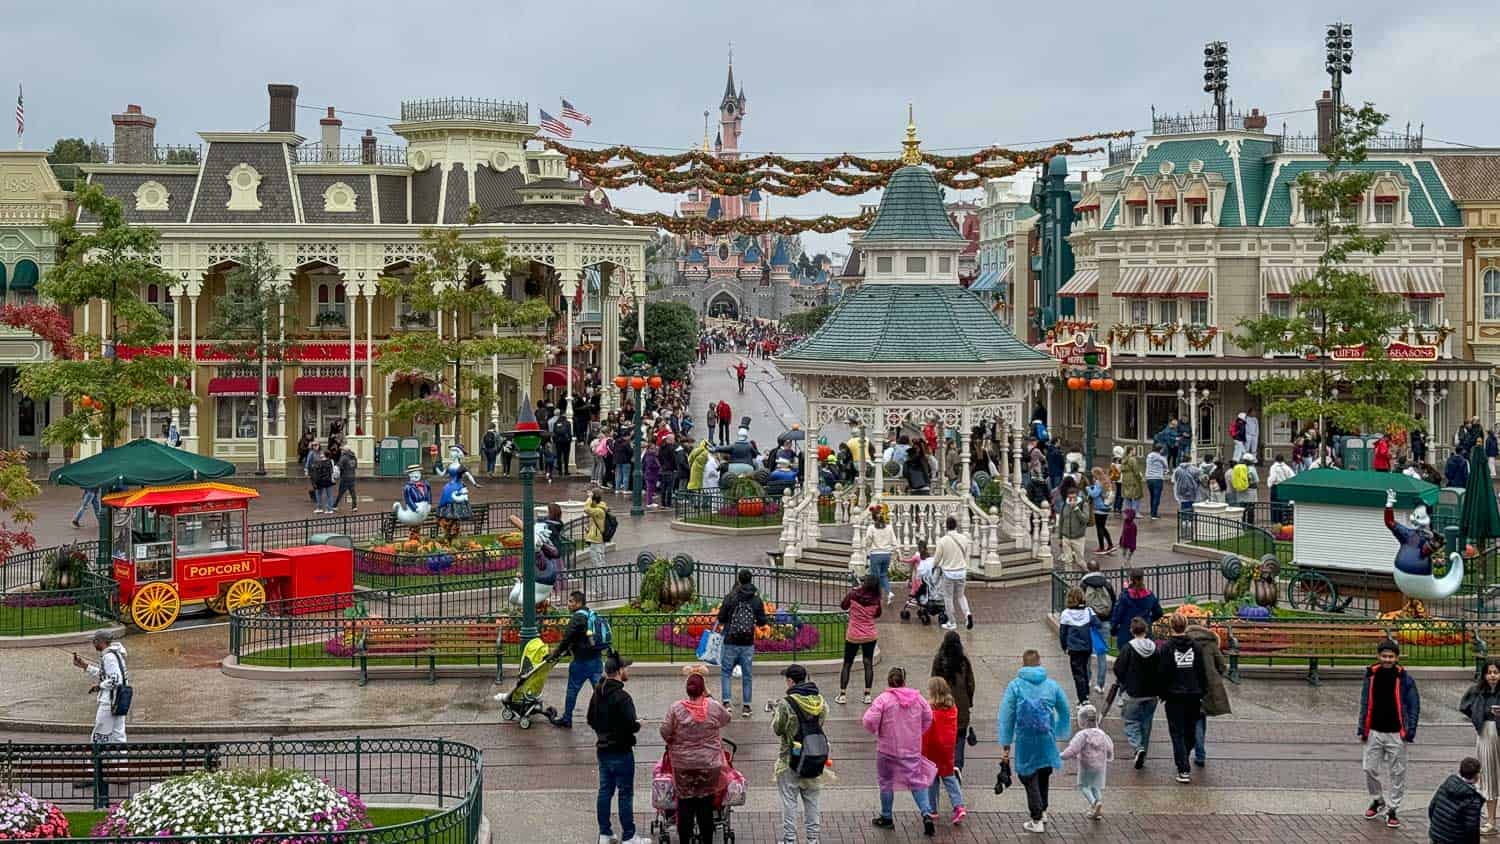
[375,207,554,452]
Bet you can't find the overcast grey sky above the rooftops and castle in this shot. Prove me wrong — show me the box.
[0,0,1500,256]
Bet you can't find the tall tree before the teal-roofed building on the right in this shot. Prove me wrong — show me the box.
[1235,103,1422,438]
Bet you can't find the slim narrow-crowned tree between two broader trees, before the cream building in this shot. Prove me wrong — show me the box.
[209,241,296,475]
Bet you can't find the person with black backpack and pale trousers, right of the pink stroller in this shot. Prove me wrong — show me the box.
[771,663,828,843]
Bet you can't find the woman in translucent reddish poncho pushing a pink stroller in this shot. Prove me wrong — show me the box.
[662,675,731,841]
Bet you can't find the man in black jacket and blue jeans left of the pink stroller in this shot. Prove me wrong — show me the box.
[588,654,641,843]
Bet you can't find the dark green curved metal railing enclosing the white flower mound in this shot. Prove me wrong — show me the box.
[0,736,485,844]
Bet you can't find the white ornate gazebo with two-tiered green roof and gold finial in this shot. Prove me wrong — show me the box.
[776,113,1058,570]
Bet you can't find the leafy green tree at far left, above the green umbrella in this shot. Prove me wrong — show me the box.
[20,184,195,448]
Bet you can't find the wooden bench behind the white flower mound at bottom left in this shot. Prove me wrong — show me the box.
[0,742,219,810]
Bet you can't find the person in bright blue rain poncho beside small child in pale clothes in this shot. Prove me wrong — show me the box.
[996,649,1071,832]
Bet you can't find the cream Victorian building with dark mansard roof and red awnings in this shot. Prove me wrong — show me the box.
[71,85,654,471]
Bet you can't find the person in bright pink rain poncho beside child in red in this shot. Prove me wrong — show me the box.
[861,669,938,835]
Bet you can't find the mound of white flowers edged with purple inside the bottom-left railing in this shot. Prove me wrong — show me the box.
[93,769,371,844]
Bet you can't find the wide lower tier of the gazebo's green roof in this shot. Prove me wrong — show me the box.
[779,283,1052,366]
